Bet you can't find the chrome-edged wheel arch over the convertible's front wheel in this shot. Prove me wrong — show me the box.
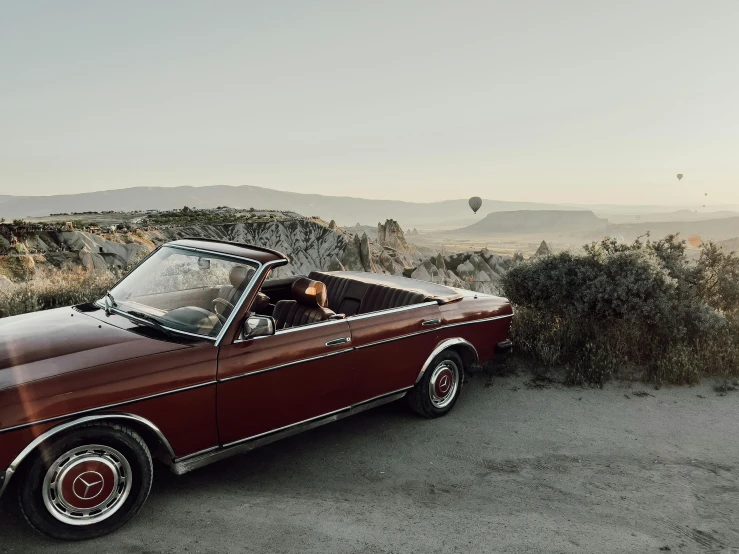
[0,413,176,495]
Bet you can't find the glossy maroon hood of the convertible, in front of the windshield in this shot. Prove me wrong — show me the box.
[0,308,185,390]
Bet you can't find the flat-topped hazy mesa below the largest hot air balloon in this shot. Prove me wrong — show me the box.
[448,210,608,236]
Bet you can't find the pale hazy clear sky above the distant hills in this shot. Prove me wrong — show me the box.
[0,0,739,204]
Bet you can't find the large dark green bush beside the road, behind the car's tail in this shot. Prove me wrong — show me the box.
[502,236,739,384]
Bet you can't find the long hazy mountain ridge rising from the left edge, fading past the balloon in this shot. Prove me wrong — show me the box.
[0,186,572,229]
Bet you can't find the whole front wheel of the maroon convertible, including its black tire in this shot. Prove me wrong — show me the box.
[18,423,154,541]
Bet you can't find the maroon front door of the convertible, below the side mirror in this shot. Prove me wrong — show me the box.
[217,320,352,445]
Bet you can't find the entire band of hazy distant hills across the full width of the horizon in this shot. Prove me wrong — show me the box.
[5,185,739,231]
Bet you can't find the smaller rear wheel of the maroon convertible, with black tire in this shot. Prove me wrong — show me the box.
[406,350,464,418]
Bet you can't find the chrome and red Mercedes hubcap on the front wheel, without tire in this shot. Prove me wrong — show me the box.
[42,444,131,525]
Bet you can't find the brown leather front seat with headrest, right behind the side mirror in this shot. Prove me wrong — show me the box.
[272,277,336,329]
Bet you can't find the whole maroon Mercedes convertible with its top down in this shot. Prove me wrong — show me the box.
[0,239,513,540]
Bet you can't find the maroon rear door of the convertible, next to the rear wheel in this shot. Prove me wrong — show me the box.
[347,302,441,404]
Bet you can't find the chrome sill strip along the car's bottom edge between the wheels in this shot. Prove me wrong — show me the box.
[173,387,412,475]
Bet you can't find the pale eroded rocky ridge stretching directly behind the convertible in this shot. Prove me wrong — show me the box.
[0,212,532,300]
